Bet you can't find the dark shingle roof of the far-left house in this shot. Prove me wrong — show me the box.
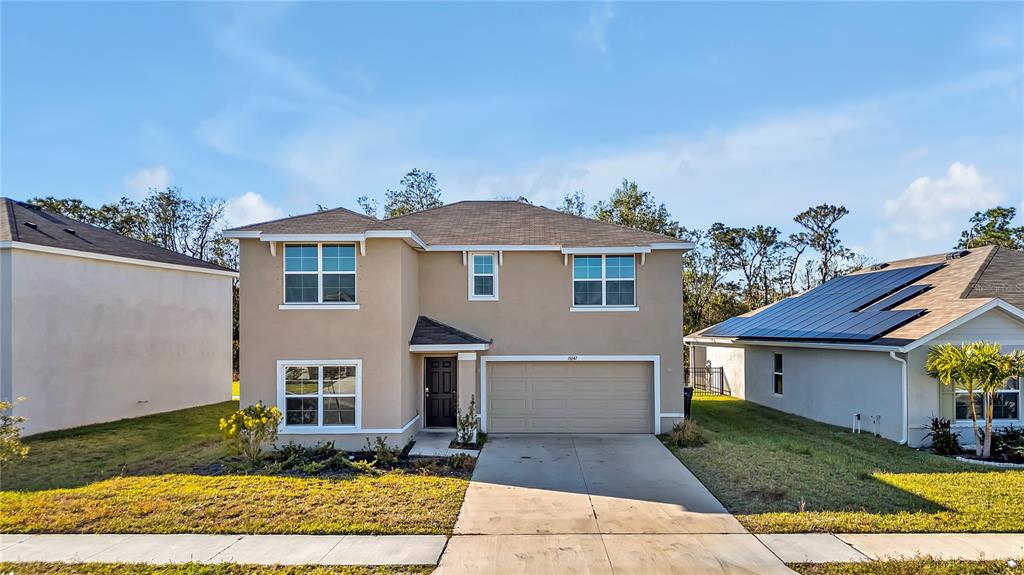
[0,197,234,271]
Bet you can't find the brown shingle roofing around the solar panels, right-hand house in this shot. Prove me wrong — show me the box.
[688,246,1024,346]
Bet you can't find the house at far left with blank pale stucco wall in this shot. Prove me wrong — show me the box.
[0,197,238,435]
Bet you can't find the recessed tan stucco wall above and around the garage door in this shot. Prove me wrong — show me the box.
[420,251,683,425]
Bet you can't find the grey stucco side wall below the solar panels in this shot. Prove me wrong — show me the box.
[744,346,902,441]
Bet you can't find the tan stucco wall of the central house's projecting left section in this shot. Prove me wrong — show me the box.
[240,235,416,449]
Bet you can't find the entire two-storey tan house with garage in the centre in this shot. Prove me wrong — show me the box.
[225,201,692,448]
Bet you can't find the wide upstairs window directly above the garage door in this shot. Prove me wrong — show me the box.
[572,256,636,307]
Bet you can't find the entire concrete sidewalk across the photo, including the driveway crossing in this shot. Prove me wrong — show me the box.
[0,533,1024,564]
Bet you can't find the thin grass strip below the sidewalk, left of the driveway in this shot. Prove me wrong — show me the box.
[0,563,434,575]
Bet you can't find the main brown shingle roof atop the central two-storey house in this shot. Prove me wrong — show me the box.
[231,201,684,248]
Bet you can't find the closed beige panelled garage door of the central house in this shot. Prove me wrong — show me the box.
[487,361,654,433]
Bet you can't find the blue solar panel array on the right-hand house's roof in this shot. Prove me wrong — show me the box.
[702,264,942,342]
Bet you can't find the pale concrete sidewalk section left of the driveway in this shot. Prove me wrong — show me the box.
[0,534,447,565]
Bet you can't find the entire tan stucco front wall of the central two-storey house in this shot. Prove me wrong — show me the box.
[240,238,682,437]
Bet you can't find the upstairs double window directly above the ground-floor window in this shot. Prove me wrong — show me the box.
[285,244,355,304]
